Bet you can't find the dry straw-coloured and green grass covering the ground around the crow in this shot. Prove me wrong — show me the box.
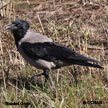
[0,0,108,108]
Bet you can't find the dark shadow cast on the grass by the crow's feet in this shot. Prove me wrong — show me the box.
[0,76,47,90]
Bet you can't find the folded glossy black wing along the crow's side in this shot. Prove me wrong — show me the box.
[21,42,98,64]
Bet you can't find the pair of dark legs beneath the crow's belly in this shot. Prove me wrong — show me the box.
[30,69,49,82]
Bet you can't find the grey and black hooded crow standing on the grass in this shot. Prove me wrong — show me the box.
[6,20,103,80]
